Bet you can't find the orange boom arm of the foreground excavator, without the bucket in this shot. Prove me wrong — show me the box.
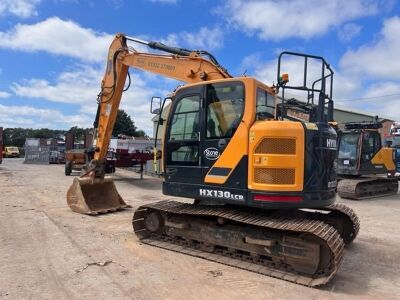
[92,34,232,171]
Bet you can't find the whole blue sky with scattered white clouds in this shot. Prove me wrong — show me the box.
[0,0,400,135]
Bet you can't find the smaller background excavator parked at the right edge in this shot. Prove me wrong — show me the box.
[337,121,399,200]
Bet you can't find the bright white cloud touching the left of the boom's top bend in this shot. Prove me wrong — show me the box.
[0,17,113,62]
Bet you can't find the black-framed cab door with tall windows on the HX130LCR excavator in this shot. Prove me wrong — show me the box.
[163,85,202,184]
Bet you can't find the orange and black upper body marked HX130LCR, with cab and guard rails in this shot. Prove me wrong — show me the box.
[152,53,336,208]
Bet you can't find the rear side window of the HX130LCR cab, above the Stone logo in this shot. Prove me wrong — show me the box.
[206,82,244,139]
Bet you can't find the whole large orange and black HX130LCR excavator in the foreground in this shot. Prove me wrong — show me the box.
[67,34,360,287]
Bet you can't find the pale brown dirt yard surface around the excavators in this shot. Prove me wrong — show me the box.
[0,159,400,300]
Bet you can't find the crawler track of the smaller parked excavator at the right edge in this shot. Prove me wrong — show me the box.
[337,178,398,200]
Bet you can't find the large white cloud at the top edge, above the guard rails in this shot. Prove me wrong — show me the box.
[217,0,385,40]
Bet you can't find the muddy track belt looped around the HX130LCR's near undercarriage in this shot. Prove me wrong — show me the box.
[132,200,344,287]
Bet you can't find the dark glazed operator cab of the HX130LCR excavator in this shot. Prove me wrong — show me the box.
[164,80,250,188]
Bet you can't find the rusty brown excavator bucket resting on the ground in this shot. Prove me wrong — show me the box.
[67,177,131,215]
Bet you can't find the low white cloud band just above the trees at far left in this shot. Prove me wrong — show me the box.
[0,104,91,129]
